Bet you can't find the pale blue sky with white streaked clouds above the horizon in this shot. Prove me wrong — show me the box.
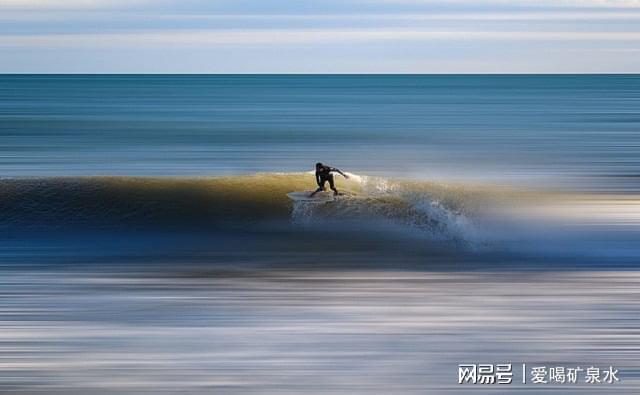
[0,0,640,73]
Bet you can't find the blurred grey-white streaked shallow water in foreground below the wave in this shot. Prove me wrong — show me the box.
[0,263,640,394]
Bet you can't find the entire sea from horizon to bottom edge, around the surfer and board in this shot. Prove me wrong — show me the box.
[0,75,640,394]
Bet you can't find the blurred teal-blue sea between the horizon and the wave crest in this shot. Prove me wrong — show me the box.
[5,75,640,191]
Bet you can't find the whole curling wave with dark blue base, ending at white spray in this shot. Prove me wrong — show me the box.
[0,173,492,268]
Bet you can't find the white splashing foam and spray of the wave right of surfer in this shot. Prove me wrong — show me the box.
[291,174,478,242]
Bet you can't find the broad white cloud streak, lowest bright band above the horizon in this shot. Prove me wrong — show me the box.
[0,29,640,48]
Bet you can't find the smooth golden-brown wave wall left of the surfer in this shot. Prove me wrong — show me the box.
[0,174,304,228]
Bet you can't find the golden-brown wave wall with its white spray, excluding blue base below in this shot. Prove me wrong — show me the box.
[0,173,480,239]
